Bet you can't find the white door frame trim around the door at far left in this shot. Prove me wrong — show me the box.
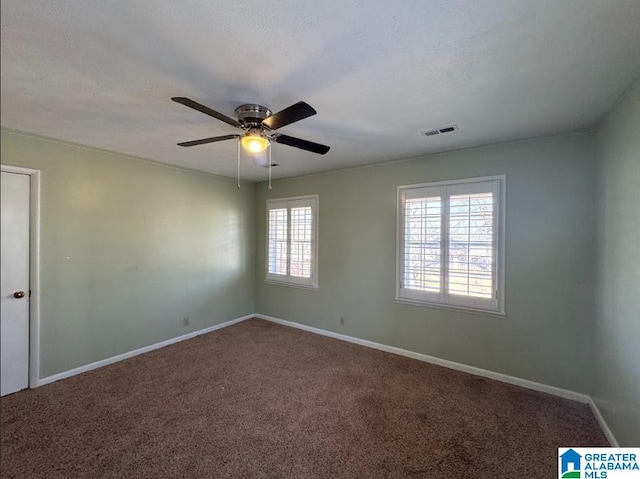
[0,164,40,389]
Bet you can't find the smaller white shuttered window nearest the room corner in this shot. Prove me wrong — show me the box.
[266,195,318,289]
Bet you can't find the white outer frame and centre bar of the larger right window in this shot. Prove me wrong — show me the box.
[395,175,507,317]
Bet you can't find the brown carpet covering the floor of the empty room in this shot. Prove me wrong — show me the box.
[0,319,608,479]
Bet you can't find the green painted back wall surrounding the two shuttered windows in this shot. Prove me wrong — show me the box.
[256,133,595,393]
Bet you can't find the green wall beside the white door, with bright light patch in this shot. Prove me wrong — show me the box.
[1,130,255,377]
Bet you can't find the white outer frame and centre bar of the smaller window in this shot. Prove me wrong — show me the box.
[264,195,320,291]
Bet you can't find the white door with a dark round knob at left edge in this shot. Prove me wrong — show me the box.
[0,171,31,396]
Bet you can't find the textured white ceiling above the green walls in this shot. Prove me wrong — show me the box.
[1,0,640,181]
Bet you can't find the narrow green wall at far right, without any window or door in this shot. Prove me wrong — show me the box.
[593,79,640,446]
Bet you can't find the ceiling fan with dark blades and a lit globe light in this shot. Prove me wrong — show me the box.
[172,96,329,155]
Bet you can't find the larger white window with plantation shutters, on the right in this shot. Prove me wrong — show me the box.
[396,176,506,314]
